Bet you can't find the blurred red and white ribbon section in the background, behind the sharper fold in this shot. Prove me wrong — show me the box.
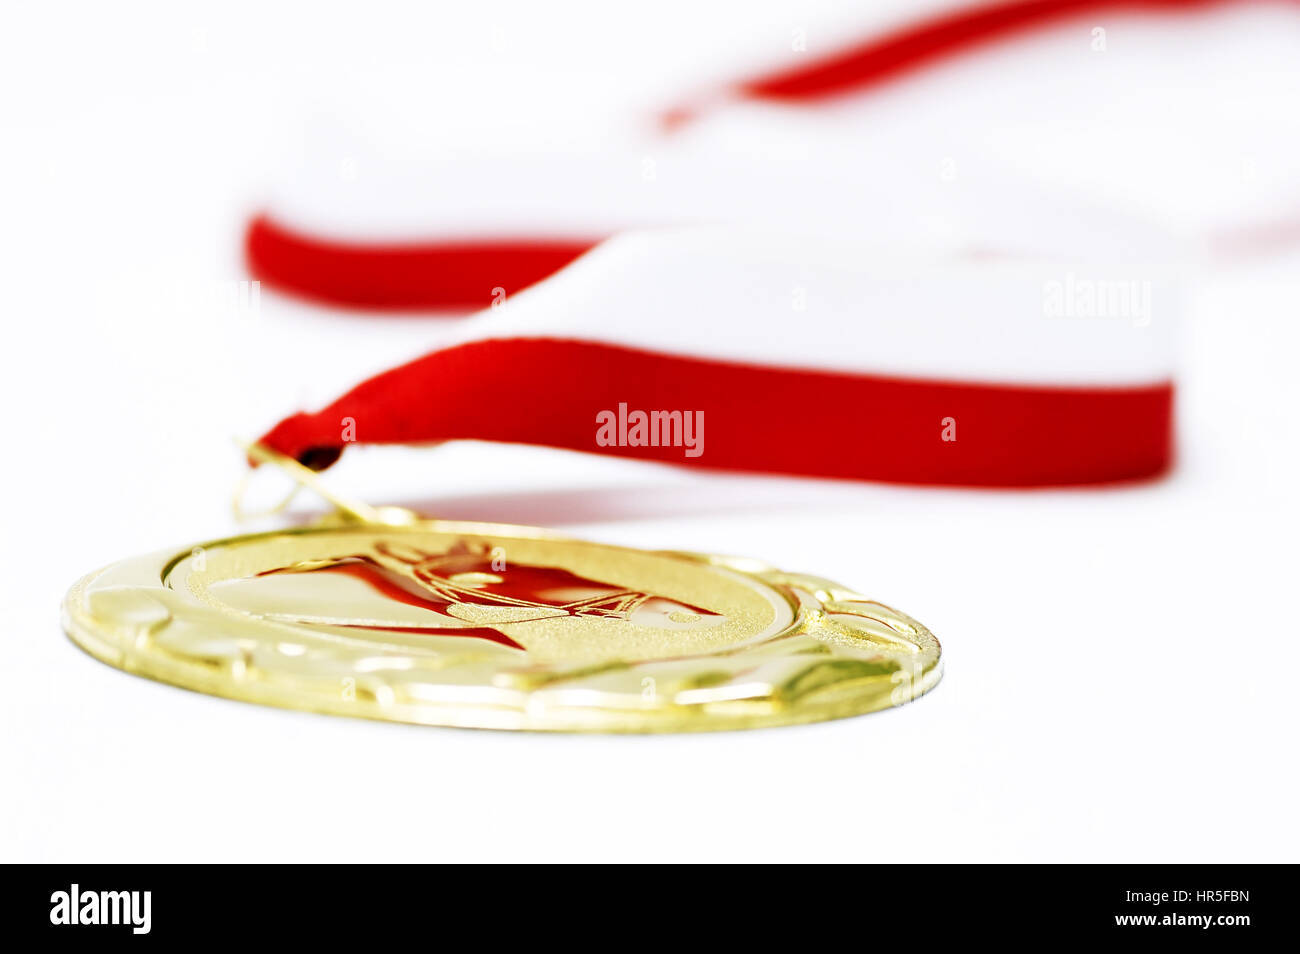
[247,0,1300,311]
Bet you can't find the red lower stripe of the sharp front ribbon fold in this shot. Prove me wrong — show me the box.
[261,338,1174,487]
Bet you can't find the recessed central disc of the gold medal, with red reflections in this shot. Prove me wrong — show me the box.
[180,530,793,665]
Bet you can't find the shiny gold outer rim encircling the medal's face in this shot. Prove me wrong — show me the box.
[62,519,943,734]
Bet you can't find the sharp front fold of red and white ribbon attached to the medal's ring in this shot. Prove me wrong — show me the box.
[263,229,1178,486]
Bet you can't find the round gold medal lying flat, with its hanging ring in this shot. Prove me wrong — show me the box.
[64,447,940,732]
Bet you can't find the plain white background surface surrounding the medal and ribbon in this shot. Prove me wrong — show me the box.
[0,1,1300,862]
